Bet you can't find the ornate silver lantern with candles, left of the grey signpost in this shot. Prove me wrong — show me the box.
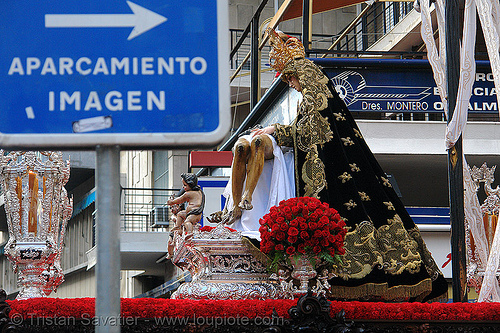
[0,151,73,299]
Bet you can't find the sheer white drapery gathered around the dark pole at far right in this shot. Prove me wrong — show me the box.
[420,0,500,301]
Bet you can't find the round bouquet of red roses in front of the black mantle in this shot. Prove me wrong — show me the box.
[259,197,347,270]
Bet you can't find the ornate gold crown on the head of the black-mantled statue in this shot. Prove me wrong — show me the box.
[267,28,306,72]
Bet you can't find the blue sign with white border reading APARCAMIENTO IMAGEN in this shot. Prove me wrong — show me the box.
[0,0,230,149]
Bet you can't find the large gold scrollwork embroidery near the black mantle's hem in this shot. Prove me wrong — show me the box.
[335,214,422,280]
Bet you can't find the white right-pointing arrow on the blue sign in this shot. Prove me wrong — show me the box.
[45,1,167,40]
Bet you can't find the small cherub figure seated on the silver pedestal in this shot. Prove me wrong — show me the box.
[167,173,205,238]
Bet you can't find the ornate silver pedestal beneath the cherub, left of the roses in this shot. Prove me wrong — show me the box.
[171,224,286,299]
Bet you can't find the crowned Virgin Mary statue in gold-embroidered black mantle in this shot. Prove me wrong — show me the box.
[224,30,448,301]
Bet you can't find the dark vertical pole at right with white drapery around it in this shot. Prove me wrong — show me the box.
[445,0,467,302]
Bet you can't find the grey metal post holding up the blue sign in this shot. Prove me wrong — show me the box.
[95,145,120,333]
